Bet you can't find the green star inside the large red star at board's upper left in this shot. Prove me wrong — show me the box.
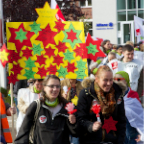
[15,29,27,42]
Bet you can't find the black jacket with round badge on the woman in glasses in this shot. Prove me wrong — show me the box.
[15,101,76,144]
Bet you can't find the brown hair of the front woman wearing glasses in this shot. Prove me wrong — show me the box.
[42,75,66,104]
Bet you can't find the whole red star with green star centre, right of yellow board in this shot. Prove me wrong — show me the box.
[84,33,106,61]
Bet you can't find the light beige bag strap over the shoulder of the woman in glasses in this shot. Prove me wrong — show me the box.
[29,99,41,143]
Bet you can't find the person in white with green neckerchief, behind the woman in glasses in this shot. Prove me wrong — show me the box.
[16,79,43,133]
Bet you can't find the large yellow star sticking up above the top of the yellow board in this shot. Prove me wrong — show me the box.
[36,2,58,23]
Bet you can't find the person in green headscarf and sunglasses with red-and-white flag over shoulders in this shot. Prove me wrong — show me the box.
[114,71,144,144]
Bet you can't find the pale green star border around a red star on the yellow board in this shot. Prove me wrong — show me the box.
[63,23,82,48]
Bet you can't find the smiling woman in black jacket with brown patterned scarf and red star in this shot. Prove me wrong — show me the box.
[77,65,126,144]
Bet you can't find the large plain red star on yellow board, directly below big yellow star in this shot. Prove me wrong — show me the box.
[36,24,57,47]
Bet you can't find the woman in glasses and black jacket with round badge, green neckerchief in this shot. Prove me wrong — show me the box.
[15,75,77,144]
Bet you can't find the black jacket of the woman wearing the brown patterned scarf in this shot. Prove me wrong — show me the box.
[77,82,126,144]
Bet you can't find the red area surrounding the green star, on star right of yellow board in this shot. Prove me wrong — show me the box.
[84,33,106,61]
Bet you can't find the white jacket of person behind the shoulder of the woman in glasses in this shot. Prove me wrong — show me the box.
[16,86,40,133]
